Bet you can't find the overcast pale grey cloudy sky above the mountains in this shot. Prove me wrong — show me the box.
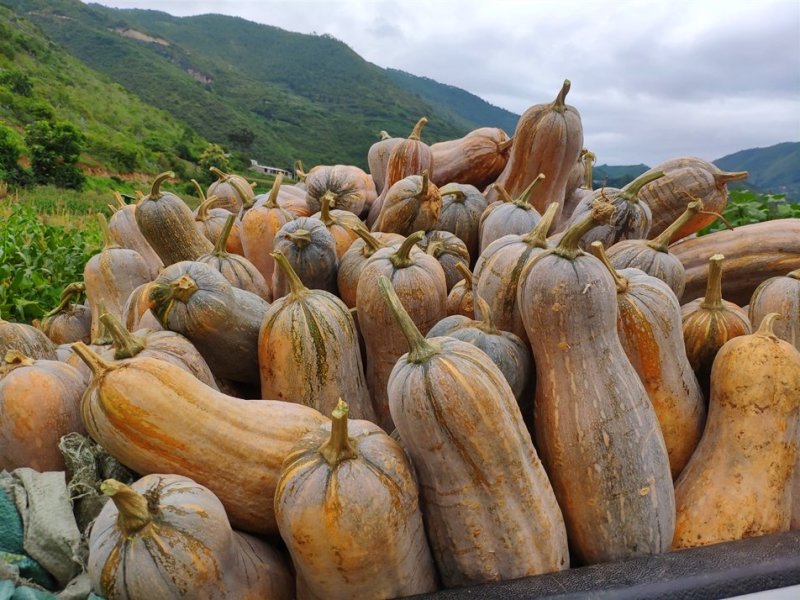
[90,0,800,165]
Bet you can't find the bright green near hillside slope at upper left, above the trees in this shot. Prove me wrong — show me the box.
[0,6,207,173]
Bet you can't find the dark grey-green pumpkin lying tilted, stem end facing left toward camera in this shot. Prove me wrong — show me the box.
[149,261,269,383]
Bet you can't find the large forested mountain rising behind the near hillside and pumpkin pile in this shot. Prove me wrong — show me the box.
[0,0,516,167]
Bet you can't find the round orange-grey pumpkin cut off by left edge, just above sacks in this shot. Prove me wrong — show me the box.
[0,350,86,472]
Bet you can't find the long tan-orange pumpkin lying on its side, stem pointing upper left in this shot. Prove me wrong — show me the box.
[74,342,327,534]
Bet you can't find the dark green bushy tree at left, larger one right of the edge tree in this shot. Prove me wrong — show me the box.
[25,121,86,190]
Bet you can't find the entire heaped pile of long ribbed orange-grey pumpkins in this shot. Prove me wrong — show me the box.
[0,81,800,599]
